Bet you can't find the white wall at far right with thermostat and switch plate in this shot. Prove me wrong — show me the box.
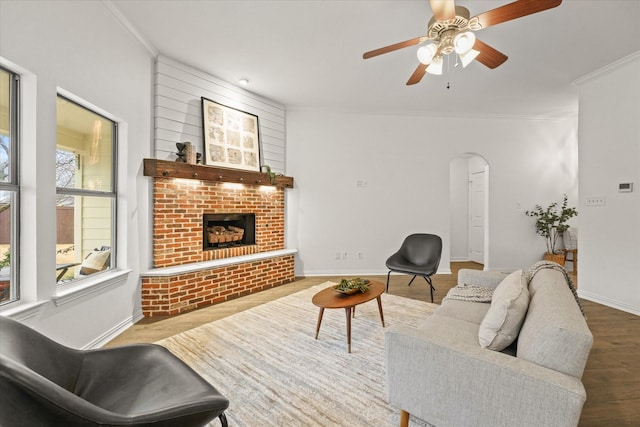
[577,52,640,314]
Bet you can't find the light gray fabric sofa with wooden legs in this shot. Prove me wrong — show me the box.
[385,269,593,427]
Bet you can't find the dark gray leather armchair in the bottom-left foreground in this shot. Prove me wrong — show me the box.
[0,316,229,427]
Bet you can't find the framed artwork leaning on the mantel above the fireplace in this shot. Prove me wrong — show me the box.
[202,97,260,172]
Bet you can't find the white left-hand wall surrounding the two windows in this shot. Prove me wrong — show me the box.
[0,1,153,347]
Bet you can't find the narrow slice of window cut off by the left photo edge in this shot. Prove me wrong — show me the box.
[0,68,20,304]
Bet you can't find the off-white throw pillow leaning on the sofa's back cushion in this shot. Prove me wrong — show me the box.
[478,270,529,351]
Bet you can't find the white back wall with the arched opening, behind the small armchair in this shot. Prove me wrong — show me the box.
[286,109,578,275]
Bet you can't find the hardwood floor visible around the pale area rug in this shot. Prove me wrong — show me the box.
[107,262,640,427]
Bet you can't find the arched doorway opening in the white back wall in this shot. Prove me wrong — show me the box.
[449,153,489,270]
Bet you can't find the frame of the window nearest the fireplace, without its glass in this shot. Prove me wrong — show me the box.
[56,94,119,292]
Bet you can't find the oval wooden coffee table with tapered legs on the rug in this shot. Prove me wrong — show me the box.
[311,281,385,353]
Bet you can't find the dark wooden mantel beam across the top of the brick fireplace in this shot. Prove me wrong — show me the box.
[143,159,293,188]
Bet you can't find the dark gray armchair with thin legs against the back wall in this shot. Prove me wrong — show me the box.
[386,233,442,302]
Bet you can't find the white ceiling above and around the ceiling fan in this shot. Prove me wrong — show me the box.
[111,0,640,117]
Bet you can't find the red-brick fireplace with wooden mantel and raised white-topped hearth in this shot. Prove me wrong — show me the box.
[142,159,295,317]
